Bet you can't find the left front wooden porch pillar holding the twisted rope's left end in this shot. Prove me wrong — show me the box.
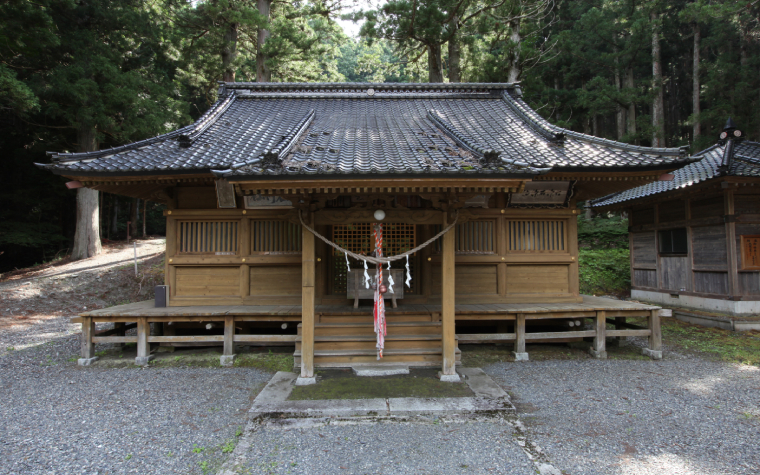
[299,215,315,383]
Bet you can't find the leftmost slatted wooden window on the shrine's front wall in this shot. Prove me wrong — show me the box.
[179,221,238,255]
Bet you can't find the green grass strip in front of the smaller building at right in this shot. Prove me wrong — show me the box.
[662,318,760,366]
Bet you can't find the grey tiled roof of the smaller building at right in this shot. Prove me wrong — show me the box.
[589,142,760,208]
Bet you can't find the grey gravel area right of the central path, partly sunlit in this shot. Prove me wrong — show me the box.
[484,354,760,475]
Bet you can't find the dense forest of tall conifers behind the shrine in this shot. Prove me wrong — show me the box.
[0,0,760,278]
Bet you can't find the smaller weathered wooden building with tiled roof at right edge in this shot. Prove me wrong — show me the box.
[590,119,760,315]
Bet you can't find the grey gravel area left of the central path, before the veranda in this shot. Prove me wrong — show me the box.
[0,327,271,475]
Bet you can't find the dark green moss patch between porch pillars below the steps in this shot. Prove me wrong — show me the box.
[288,368,475,401]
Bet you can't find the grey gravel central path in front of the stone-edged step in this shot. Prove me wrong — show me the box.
[233,422,536,475]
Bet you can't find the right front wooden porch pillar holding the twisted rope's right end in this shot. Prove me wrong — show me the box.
[441,218,459,381]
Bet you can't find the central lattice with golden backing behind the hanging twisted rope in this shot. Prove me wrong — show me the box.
[332,223,417,294]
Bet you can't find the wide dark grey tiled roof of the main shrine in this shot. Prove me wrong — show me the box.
[40,83,691,179]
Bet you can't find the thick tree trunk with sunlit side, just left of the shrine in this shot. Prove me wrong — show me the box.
[71,126,103,261]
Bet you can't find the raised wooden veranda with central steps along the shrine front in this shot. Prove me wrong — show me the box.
[75,295,662,367]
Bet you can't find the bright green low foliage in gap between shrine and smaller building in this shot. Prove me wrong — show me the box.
[578,248,631,295]
